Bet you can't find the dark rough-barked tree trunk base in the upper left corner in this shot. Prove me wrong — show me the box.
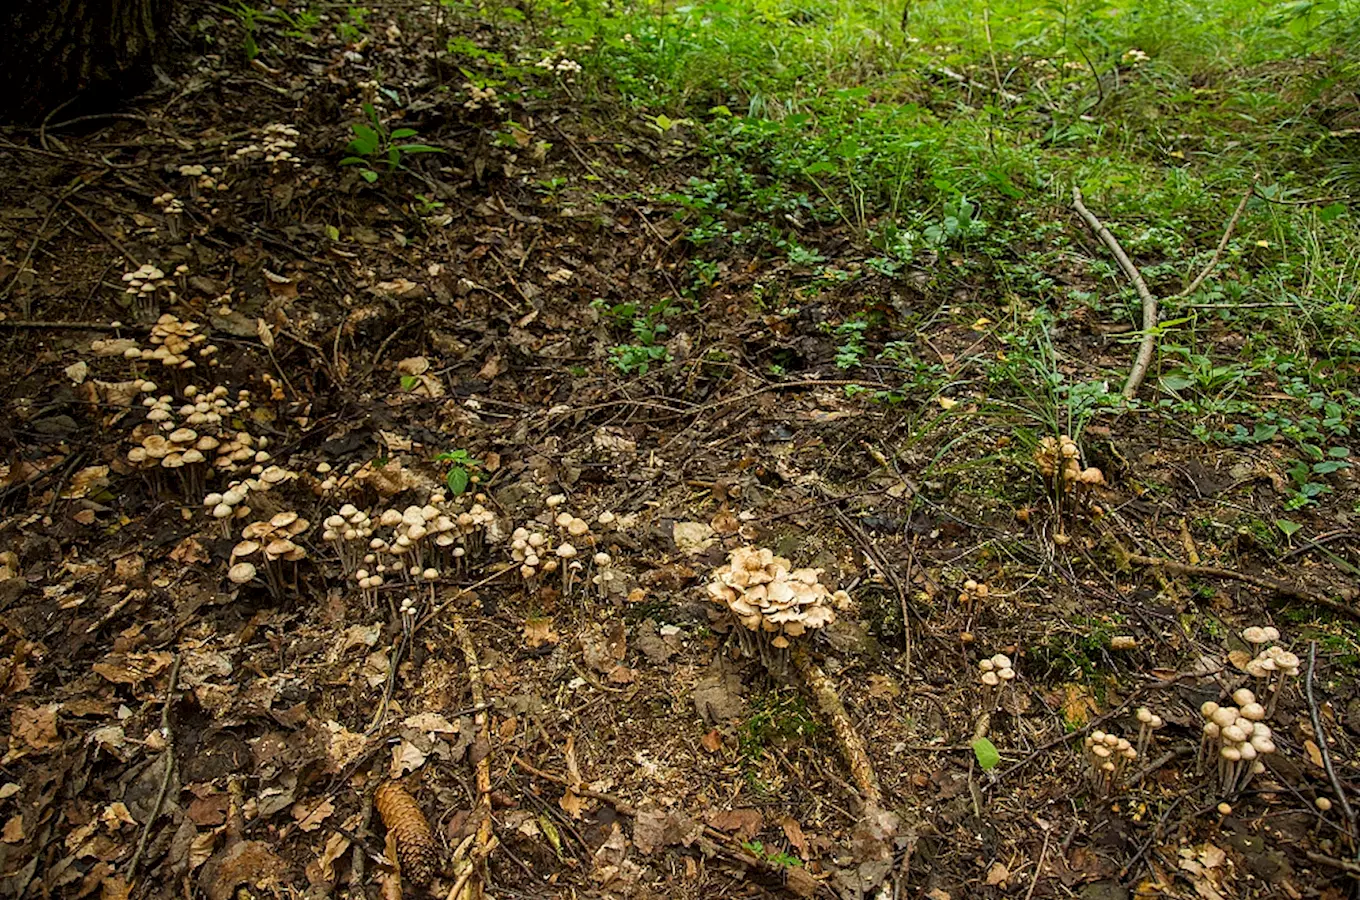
[0,0,174,121]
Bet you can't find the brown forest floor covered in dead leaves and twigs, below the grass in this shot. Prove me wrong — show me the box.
[0,3,1360,900]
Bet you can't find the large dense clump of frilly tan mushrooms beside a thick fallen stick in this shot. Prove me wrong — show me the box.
[707,547,850,670]
